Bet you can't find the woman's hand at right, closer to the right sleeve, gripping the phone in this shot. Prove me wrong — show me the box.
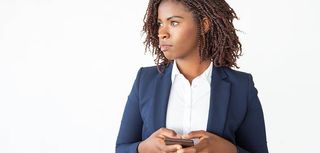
[177,131,237,153]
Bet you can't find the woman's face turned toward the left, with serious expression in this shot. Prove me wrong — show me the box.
[158,0,199,60]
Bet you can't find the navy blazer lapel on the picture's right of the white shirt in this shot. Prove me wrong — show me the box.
[207,67,230,135]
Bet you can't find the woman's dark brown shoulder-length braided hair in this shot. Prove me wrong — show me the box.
[142,0,242,72]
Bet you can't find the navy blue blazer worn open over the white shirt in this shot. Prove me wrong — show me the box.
[116,64,268,153]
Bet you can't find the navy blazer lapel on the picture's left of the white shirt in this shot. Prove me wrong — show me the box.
[152,64,173,131]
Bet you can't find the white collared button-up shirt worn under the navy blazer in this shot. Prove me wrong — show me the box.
[166,61,212,134]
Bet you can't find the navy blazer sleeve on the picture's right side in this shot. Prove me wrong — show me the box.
[236,74,268,153]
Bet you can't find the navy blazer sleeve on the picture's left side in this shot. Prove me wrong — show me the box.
[116,68,143,153]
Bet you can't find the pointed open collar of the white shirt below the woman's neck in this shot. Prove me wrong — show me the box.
[171,60,212,84]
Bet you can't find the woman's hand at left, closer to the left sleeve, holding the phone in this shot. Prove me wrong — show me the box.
[138,128,182,153]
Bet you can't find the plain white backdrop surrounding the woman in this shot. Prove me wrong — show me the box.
[0,0,320,153]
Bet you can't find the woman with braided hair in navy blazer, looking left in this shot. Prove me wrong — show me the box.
[116,0,268,153]
